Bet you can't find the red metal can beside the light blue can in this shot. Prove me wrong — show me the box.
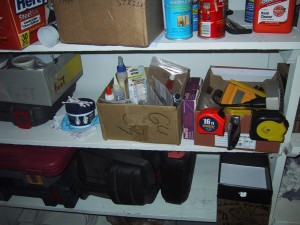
[198,0,228,38]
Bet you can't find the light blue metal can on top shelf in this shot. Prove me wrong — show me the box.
[164,0,193,39]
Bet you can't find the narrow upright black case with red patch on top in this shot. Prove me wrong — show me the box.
[161,151,197,204]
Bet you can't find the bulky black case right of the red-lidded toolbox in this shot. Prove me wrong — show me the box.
[77,149,160,205]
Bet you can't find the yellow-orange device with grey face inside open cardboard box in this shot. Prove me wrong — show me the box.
[221,80,266,104]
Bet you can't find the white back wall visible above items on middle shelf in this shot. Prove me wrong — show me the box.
[76,52,282,99]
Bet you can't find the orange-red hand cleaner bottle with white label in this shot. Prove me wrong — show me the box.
[253,0,296,33]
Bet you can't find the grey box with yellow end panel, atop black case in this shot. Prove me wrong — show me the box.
[0,53,83,106]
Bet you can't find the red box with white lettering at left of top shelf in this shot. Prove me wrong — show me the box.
[0,0,47,50]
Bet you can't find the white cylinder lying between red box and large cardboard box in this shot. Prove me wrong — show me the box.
[37,22,59,48]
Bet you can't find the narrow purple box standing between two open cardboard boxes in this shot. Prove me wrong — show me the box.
[182,77,202,140]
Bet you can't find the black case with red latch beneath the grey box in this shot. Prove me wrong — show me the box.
[0,83,76,129]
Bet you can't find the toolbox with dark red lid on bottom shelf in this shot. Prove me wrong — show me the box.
[0,144,79,208]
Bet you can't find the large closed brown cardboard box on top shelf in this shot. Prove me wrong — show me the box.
[53,0,163,47]
